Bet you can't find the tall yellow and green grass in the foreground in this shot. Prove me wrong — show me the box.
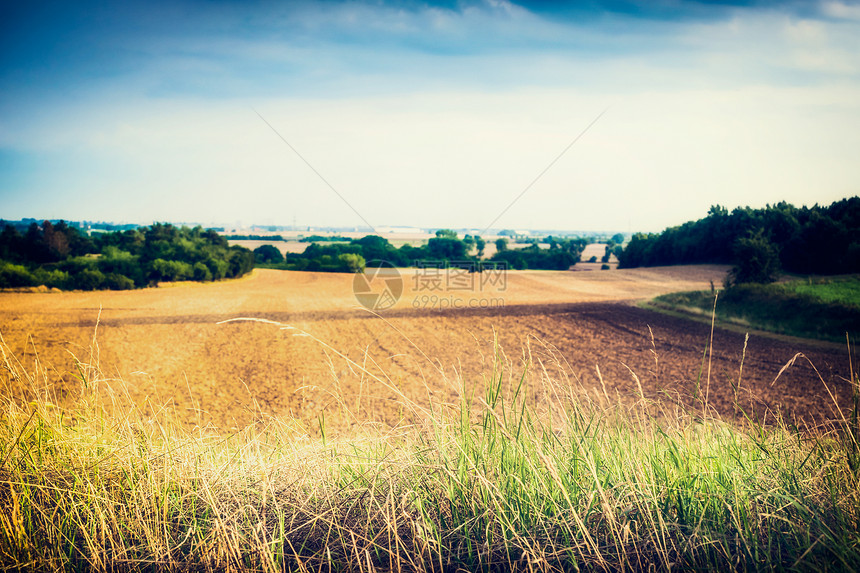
[0,326,860,571]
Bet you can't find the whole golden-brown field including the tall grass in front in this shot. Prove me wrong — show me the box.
[0,267,860,573]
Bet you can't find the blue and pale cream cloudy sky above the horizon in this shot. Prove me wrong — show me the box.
[0,0,860,232]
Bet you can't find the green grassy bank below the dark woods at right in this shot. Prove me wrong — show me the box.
[650,277,860,342]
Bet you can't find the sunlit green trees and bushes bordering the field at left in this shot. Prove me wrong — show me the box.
[0,221,254,290]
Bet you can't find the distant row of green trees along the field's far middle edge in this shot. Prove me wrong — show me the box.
[254,229,588,272]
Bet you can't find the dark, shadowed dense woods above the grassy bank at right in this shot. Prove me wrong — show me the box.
[618,197,860,282]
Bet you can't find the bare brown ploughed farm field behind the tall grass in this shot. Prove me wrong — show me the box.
[0,266,849,431]
